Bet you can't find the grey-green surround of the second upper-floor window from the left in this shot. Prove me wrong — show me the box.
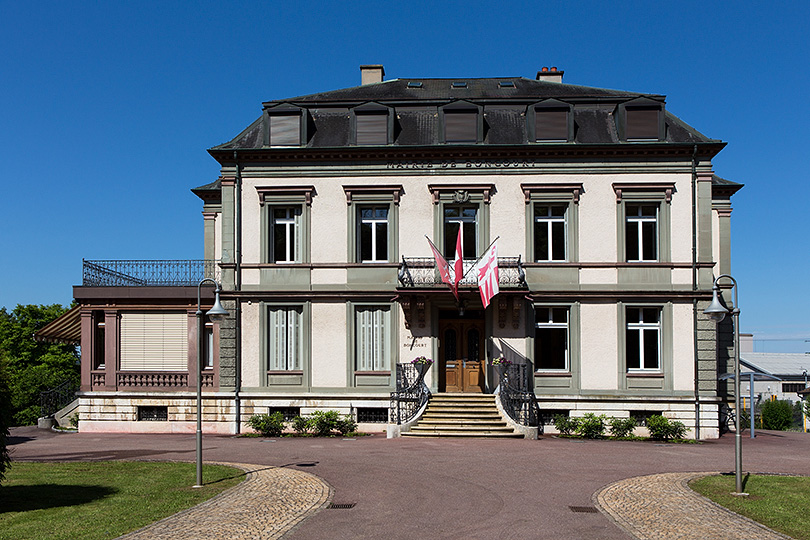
[343,185,403,265]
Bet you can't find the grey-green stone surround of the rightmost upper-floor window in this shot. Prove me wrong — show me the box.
[613,183,675,265]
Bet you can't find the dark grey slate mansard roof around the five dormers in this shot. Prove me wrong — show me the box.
[210,77,723,155]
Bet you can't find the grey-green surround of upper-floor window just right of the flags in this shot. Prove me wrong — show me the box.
[520,184,582,264]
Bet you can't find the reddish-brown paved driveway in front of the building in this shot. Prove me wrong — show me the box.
[11,428,810,540]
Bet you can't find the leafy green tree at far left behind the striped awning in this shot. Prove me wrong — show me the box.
[0,304,80,425]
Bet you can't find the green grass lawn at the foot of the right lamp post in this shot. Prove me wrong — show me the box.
[689,475,810,540]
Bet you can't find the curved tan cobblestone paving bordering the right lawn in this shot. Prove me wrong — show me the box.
[594,473,790,540]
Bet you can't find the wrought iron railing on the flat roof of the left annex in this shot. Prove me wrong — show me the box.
[82,260,221,287]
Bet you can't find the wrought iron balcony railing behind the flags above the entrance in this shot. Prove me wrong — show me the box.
[397,257,526,288]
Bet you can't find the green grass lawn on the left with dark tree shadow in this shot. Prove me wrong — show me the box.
[0,461,245,540]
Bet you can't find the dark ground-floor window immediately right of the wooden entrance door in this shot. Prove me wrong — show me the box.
[534,306,571,371]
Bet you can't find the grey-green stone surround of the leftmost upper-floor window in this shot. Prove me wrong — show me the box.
[256,186,316,266]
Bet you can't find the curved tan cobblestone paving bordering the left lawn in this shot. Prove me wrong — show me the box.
[115,463,332,540]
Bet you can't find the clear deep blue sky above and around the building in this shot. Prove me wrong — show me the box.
[0,0,810,352]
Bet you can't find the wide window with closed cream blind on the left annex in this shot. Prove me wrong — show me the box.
[120,312,188,371]
